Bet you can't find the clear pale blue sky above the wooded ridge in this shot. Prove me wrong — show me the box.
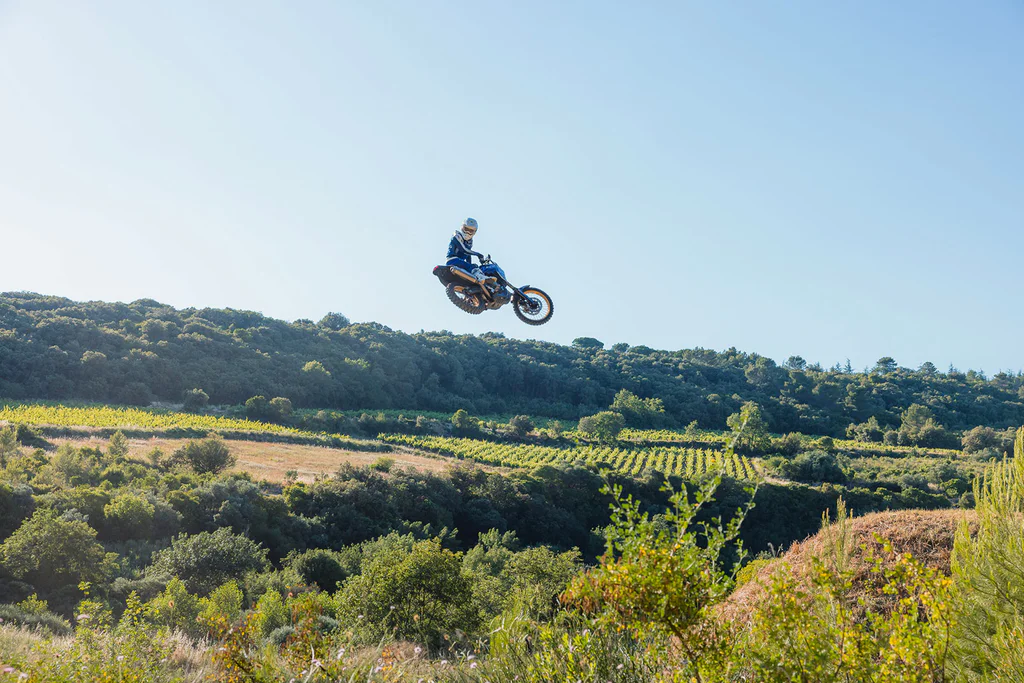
[0,0,1024,373]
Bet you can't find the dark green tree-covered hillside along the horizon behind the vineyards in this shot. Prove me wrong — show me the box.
[0,293,1024,436]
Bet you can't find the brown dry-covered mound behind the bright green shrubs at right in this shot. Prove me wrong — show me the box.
[722,510,974,623]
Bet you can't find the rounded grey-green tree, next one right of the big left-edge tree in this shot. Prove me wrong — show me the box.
[145,527,270,595]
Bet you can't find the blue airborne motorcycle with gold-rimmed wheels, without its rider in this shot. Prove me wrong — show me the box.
[434,254,555,325]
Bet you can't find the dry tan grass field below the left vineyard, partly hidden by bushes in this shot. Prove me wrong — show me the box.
[50,436,498,483]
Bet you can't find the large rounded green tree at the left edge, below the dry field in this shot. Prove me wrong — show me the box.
[0,508,116,591]
